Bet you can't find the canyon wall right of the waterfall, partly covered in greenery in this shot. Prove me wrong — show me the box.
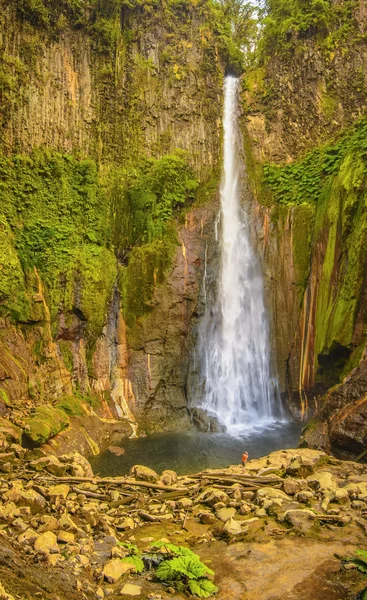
[242,2,367,453]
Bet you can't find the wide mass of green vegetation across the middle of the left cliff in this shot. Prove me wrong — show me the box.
[0,150,199,342]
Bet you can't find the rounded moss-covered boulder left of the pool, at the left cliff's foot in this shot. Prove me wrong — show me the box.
[25,406,70,444]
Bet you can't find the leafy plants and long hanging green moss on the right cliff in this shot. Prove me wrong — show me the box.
[264,119,367,385]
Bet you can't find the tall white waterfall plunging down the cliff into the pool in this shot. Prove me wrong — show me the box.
[199,76,277,431]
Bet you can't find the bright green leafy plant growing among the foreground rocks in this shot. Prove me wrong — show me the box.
[120,542,218,598]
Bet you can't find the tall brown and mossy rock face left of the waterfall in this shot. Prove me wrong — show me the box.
[0,1,224,440]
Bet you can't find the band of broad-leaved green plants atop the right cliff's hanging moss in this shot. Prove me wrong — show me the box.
[263,119,367,204]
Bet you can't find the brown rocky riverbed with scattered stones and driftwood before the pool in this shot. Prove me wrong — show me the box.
[0,444,367,600]
